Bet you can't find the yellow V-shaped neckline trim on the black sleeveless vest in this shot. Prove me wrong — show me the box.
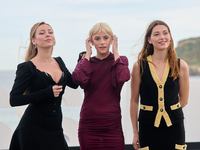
[147,55,170,84]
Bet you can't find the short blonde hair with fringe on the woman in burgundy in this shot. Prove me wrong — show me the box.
[89,22,113,37]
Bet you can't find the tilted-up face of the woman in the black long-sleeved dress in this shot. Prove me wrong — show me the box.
[32,24,55,48]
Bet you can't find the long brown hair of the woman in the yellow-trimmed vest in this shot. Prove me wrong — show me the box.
[138,20,180,80]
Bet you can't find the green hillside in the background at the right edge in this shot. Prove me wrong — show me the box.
[176,37,200,75]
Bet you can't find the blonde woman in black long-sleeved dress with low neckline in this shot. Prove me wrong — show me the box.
[9,22,78,150]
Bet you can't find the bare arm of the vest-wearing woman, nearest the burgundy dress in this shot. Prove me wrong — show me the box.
[130,62,141,150]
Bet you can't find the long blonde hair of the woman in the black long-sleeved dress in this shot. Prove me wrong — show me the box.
[25,22,51,62]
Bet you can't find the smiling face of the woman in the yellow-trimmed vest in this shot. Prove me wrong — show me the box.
[148,25,171,50]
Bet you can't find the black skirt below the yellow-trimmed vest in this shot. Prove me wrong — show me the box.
[139,118,185,150]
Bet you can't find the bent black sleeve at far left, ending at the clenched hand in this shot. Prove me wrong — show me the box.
[10,62,54,106]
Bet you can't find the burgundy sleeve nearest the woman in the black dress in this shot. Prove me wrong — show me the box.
[72,58,92,89]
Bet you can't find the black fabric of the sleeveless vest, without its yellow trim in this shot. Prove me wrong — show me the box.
[138,59,184,125]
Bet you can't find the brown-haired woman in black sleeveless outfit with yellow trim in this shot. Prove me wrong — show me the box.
[130,20,189,150]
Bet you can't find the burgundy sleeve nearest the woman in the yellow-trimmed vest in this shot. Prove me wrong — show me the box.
[112,56,130,87]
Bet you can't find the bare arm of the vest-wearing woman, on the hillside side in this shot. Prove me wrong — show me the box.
[179,60,189,108]
